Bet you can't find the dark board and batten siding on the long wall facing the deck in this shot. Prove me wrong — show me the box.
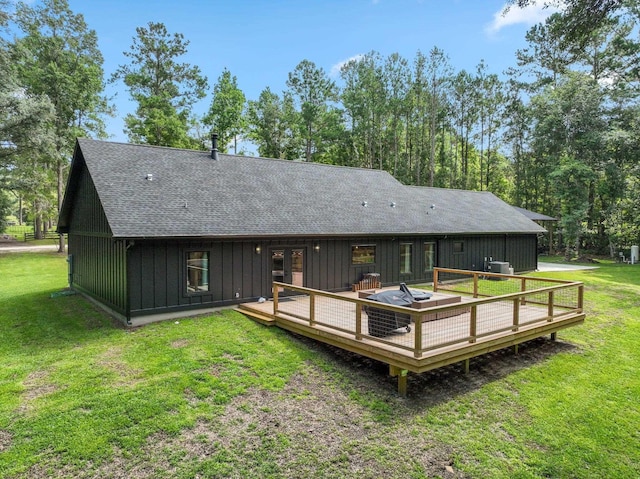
[122,235,536,317]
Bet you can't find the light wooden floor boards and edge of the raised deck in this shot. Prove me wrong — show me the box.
[238,280,585,396]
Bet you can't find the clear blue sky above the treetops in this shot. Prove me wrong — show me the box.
[69,0,551,141]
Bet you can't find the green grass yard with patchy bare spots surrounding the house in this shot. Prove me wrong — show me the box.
[0,253,640,478]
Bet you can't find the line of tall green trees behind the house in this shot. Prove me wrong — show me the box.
[0,0,640,255]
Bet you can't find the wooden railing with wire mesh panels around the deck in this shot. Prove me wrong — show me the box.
[273,268,583,358]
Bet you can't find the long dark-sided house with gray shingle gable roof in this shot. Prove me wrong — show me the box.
[58,139,545,325]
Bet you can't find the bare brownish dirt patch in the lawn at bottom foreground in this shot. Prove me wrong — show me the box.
[74,364,465,479]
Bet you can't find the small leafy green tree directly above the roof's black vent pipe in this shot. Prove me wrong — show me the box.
[203,68,246,154]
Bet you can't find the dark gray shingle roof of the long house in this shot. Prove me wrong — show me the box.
[61,139,544,238]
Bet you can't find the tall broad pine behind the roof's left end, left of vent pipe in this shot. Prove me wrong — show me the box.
[111,22,207,148]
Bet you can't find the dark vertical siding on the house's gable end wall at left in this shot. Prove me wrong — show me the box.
[68,163,127,315]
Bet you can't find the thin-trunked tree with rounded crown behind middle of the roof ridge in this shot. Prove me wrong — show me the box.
[287,60,338,161]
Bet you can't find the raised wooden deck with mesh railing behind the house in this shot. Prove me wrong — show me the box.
[238,271,585,394]
